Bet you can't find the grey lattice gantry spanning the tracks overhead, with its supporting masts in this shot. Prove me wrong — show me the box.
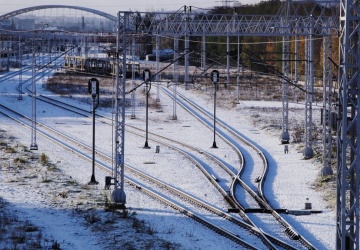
[116,0,339,203]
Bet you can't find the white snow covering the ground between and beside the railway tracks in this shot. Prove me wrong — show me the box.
[0,67,336,249]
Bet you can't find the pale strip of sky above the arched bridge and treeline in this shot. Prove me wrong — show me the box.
[0,0,260,15]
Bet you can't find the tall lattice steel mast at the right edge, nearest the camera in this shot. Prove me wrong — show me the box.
[336,0,360,250]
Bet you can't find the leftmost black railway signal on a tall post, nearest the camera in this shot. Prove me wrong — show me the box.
[88,78,99,185]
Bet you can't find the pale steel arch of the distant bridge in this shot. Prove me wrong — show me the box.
[0,5,116,22]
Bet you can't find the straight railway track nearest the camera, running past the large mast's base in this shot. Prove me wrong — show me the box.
[0,101,268,249]
